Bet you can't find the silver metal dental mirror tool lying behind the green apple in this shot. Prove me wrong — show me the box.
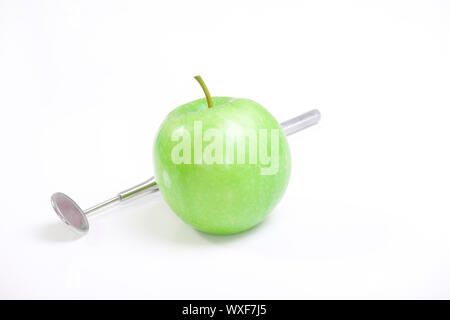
[51,109,320,233]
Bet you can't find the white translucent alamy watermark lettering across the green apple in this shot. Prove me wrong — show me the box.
[171,121,280,175]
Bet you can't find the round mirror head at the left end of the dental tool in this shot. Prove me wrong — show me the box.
[51,192,89,233]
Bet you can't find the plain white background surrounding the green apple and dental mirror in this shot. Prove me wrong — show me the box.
[0,0,450,299]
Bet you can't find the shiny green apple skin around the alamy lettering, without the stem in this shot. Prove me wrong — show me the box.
[153,97,291,235]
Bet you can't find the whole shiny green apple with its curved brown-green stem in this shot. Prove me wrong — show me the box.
[153,76,291,234]
